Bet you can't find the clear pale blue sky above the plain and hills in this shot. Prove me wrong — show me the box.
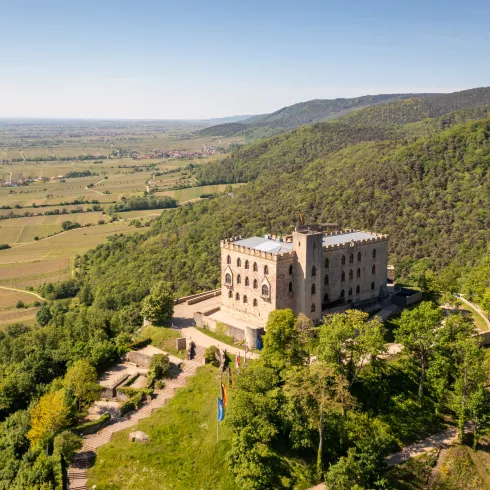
[0,0,490,119]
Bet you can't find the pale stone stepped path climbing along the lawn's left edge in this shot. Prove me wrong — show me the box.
[68,361,202,490]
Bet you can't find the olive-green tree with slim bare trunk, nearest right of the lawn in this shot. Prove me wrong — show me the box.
[283,362,353,479]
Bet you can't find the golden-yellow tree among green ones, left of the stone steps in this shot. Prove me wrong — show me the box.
[27,390,70,447]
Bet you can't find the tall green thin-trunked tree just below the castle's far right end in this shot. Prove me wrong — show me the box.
[395,301,442,403]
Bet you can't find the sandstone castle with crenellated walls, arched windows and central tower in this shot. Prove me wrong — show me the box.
[221,225,388,330]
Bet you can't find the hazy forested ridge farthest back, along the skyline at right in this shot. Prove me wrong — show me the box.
[200,87,490,140]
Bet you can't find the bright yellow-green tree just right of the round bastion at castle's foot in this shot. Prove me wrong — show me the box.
[260,309,305,369]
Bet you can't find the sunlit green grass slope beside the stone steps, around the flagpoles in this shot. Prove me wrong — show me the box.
[87,365,238,490]
